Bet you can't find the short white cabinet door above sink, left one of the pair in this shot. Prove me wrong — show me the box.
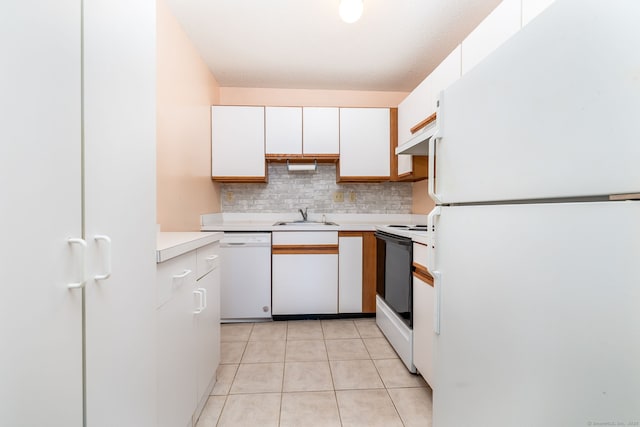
[265,107,302,154]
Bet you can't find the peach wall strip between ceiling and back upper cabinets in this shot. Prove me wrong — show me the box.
[220,87,409,108]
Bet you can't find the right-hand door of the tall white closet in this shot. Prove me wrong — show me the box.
[84,0,156,427]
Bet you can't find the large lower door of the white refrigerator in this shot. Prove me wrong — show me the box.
[430,202,640,427]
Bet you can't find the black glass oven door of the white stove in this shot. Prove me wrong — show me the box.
[376,231,413,327]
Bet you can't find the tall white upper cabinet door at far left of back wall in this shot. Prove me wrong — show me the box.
[211,106,266,182]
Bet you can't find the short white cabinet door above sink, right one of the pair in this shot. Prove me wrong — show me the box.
[302,107,340,156]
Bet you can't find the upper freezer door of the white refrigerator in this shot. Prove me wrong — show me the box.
[429,0,640,204]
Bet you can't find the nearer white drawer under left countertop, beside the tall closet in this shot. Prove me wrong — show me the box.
[156,251,197,307]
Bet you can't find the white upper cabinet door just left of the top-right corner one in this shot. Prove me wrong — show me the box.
[462,0,522,74]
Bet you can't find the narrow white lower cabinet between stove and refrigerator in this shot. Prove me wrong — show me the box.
[413,243,435,388]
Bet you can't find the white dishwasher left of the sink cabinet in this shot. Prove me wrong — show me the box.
[220,232,271,322]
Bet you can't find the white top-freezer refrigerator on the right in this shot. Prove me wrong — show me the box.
[428,0,640,427]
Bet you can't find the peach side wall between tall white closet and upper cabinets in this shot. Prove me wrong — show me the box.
[157,0,220,231]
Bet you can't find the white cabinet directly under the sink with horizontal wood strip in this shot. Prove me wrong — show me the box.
[271,231,338,315]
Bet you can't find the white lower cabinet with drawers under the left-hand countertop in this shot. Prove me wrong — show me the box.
[156,244,220,427]
